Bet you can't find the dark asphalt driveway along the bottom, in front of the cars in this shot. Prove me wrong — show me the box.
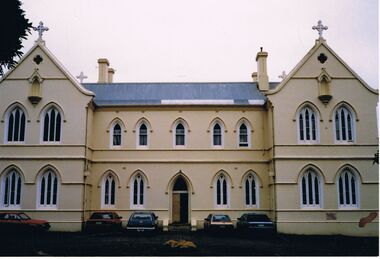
[0,231,379,256]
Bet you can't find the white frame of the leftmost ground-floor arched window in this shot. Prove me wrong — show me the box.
[0,168,24,210]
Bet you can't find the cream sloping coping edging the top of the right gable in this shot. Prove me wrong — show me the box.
[266,39,379,95]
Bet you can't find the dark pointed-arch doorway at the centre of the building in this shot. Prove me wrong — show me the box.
[172,176,189,224]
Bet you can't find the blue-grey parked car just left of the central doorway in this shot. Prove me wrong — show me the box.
[127,211,158,232]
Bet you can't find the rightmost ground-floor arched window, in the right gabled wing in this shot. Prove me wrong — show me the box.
[338,169,359,207]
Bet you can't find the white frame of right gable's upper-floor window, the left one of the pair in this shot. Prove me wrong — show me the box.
[297,106,319,144]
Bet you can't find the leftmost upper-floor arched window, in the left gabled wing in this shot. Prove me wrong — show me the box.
[6,107,26,142]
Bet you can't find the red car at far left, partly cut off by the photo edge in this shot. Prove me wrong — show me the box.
[0,212,50,233]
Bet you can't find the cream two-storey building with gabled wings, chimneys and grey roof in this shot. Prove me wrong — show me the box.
[0,25,378,236]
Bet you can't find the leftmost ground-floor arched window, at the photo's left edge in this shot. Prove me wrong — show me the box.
[1,169,22,207]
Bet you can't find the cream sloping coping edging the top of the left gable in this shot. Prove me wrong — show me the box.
[0,40,94,96]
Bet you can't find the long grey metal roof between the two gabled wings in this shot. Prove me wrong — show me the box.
[82,82,266,106]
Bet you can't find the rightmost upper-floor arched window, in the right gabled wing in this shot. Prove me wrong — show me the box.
[334,106,355,142]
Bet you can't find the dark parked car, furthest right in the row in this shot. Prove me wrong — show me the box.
[236,213,276,234]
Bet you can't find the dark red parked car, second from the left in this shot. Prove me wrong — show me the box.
[85,211,122,231]
